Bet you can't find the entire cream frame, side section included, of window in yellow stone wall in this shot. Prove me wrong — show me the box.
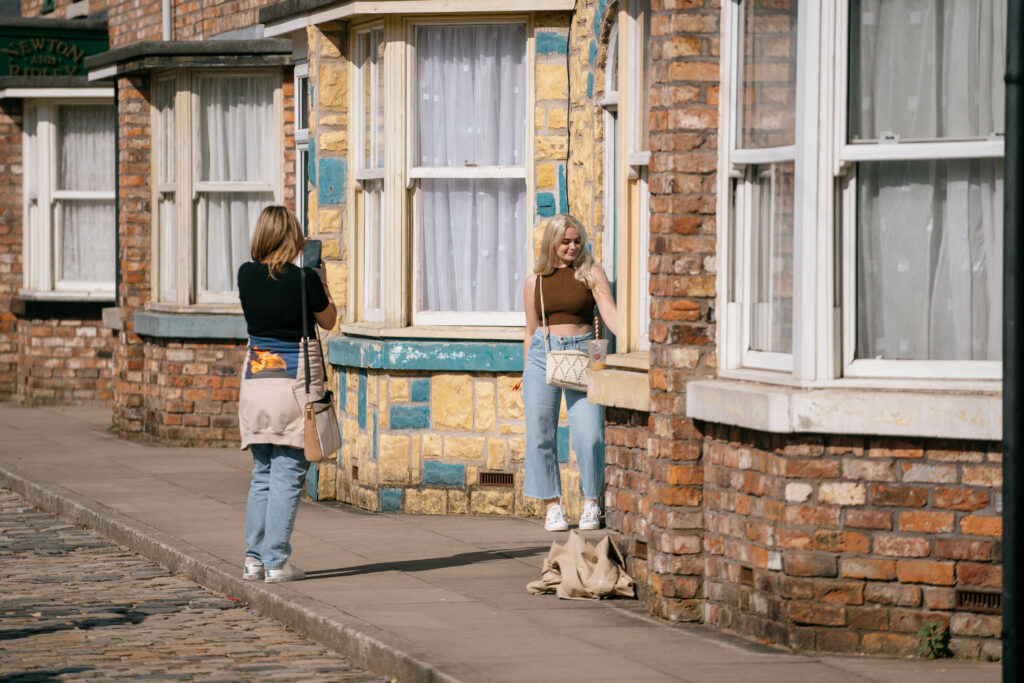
[346,14,536,327]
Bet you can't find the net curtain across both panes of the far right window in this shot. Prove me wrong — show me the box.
[850,0,1007,360]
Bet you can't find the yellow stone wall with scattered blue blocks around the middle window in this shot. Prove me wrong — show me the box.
[296,7,615,519]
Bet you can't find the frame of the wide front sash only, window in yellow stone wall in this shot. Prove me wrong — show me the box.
[404,16,534,327]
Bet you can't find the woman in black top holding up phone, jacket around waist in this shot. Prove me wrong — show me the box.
[238,206,338,584]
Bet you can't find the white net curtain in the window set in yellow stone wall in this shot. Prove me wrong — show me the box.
[414,25,526,311]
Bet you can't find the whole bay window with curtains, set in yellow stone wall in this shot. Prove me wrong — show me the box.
[352,17,532,326]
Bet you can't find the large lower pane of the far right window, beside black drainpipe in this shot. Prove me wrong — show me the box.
[857,159,1002,360]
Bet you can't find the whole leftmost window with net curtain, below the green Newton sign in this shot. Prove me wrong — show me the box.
[24,99,116,299]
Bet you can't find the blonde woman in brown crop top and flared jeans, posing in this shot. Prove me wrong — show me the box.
[522,214,617,531]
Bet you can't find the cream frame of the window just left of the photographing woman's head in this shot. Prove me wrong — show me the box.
[148,68,285,312]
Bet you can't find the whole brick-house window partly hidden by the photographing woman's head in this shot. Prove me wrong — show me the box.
[153,71,283,307]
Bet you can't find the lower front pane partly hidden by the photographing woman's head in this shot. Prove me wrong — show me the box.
[197,194,273,292]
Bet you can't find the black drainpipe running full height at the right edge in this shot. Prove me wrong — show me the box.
[1002,2,1024,683]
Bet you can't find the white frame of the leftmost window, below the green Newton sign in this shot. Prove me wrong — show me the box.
[20,94,118,301]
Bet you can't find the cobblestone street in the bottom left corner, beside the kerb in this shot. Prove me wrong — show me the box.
[0,488,388,683]
